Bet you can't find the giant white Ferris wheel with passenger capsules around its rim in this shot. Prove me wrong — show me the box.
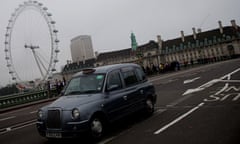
[4,0,59,85]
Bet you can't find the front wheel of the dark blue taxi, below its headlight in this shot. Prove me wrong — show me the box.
[89,116,105,141]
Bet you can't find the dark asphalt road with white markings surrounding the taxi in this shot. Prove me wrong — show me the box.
[0,59,240,144]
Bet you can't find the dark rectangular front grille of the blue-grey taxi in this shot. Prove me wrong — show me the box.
[47,109,61,129]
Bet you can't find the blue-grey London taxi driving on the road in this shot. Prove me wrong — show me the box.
[36,64,157,139]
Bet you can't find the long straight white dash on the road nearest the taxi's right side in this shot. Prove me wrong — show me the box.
[154,103,204,135]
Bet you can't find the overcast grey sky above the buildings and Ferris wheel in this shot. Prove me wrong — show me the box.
[0,0,240,86]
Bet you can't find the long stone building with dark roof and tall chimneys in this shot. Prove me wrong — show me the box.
[62,20,240,78]
